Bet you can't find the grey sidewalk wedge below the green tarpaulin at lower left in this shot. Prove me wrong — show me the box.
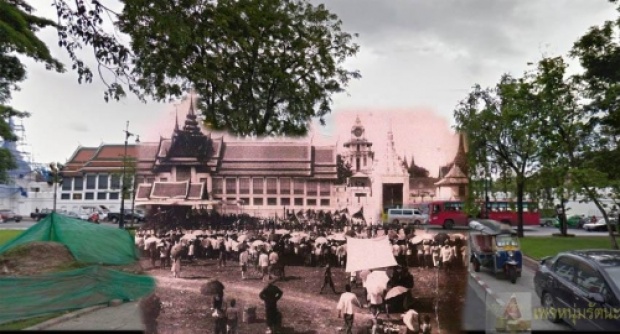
[27,302,144,331]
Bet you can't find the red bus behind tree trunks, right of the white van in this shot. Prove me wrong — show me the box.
[428,201,540,229]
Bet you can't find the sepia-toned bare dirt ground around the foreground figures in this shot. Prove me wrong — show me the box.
[141,260,467,334]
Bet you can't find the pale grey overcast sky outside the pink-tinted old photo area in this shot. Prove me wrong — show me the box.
[7,0,617,166]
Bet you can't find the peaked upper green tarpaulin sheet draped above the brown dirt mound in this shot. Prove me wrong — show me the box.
[0,213,138,265]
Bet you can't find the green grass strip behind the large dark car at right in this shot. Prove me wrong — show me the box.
[520,236,611,260]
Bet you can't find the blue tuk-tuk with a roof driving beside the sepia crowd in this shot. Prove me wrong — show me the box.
[469,219,523,283]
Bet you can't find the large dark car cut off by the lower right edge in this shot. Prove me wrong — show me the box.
[534,249,620,332]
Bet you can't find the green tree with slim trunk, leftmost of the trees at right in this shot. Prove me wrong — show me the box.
[454,75,540,237]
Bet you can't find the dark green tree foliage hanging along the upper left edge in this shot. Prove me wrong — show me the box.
[0,0,63,183]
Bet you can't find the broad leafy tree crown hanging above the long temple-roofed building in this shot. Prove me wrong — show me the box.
[118,0,360,136]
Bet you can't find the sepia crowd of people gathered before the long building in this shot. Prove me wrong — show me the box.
[136,207,468,334]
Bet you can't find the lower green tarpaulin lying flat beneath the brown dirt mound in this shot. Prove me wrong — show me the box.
[0,266,155,323]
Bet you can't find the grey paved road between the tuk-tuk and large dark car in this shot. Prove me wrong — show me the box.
[472,267,570,331]
